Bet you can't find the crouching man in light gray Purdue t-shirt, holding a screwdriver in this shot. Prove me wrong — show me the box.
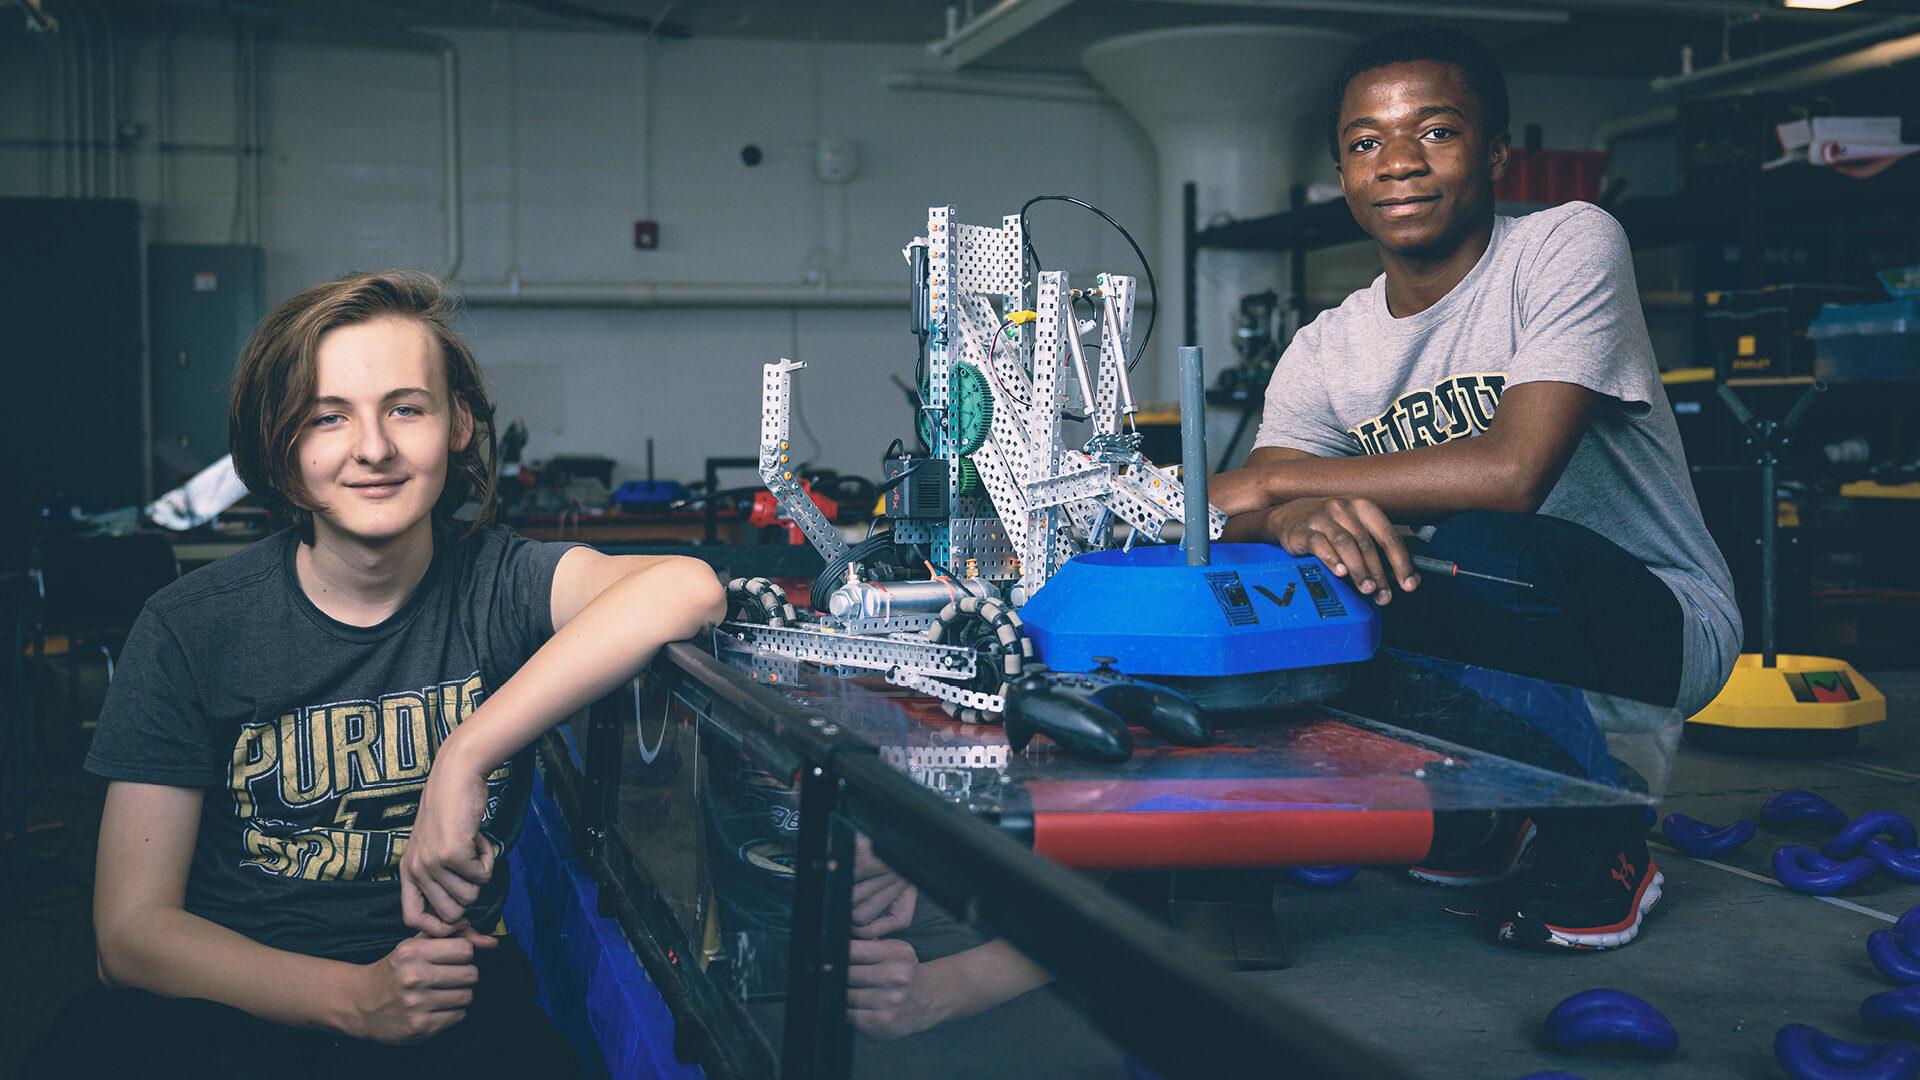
[1212,25,1740,949]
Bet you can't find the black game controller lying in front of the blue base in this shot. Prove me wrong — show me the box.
[1006,657,1213,765]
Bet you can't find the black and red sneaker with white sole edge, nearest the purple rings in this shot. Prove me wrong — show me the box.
[1496,836,1667,949]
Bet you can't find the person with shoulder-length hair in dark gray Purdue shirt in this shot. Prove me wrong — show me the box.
[21,273,724,1080]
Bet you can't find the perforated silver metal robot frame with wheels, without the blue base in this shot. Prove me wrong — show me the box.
[722,206,1225,713]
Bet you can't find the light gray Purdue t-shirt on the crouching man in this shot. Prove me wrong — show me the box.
[1254,202,1740,715]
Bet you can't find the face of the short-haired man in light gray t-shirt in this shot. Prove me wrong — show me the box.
[1336,60,1507,265]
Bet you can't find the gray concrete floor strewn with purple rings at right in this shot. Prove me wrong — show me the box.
[1248,671,1920,1080]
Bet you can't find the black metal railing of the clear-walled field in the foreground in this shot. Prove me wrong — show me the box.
[549,644,1411,1080]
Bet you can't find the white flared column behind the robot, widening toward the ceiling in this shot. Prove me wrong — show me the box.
[1081,25,1359,413]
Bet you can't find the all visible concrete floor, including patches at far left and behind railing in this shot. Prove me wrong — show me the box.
[15,671,1920,1080]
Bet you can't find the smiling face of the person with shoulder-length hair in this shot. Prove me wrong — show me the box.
[294,309,472,548]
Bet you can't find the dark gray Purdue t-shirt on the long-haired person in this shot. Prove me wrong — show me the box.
[86,528,572,963]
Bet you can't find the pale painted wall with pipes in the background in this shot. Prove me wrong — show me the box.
[0,19,1674,488]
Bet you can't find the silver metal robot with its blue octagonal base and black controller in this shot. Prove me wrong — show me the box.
[720,208,1379,761]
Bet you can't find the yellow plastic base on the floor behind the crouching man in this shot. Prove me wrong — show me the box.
[1688,653,1887,730]
